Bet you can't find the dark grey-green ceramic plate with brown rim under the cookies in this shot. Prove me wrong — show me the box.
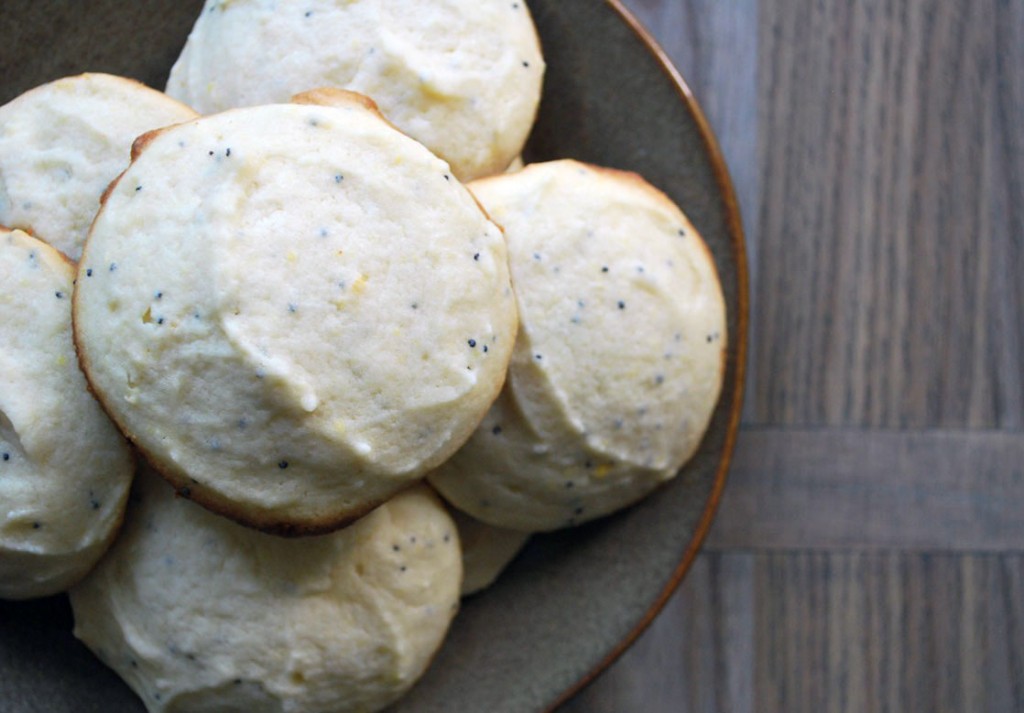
[0,0,746,713]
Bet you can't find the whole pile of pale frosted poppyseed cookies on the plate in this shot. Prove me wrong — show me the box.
[0,0,726,711]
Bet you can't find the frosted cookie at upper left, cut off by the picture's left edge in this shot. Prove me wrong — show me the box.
[0,74,197,260]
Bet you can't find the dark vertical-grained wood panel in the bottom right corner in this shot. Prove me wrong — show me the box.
[755,553,1024,712]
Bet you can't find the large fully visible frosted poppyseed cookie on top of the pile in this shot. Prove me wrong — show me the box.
[74,92,516,535]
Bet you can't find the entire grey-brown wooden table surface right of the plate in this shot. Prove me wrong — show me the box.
[560,0,1024,713]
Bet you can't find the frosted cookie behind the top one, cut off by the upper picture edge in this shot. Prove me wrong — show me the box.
[167,0,545,180]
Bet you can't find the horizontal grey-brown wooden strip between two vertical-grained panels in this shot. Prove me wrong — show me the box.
[706,427,1024,552]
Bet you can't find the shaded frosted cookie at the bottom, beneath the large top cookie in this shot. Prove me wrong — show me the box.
[71,470,462,713]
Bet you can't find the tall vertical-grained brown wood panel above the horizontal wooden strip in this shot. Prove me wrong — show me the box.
[748,0,1024,429]
